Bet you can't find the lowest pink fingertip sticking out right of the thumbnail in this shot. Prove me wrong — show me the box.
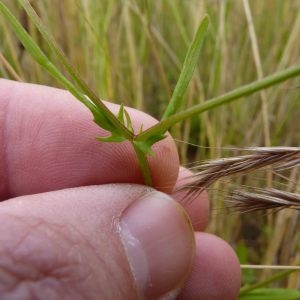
[178,233,241,300]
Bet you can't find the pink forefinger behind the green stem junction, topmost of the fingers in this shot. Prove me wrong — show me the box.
[0,80,179,199]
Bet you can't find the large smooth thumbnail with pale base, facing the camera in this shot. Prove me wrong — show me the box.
[120,191,194,299]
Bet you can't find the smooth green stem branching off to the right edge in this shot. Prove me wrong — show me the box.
[136,65,300,141]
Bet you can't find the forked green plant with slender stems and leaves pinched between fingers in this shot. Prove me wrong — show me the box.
[0,0,300,185]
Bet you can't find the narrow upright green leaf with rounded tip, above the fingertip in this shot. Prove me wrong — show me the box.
[162,16,209,120]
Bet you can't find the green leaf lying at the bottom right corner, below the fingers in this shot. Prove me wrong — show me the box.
[238,288,300,300]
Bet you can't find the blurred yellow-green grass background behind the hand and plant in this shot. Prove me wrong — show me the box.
[0,0,300,288]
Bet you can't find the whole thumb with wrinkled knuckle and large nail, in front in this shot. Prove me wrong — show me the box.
[0,184,194,299]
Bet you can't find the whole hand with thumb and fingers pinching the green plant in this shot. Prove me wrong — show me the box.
[0,80,240,300]
